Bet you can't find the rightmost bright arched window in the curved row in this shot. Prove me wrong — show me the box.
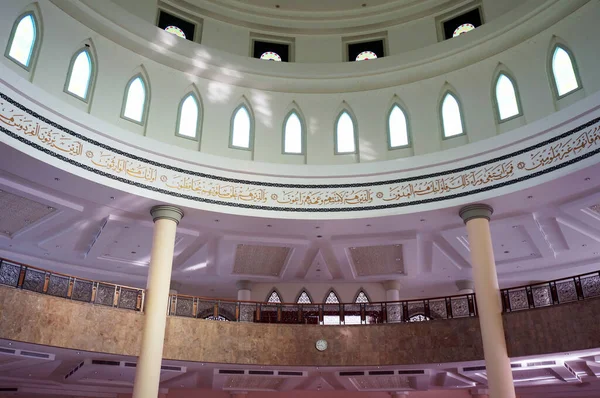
[550,44,581,98]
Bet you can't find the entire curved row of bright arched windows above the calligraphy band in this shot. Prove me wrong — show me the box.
[5,11,581,154]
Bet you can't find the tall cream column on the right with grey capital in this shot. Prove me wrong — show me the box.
[459,204,515,398]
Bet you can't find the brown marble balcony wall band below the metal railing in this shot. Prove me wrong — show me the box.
[0,286,600,366]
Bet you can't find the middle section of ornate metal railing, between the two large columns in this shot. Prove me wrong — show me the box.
[169,294,477,325]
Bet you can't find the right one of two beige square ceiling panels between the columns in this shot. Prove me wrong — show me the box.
[349,245,404,276]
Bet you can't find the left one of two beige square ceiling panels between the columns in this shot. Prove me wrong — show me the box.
[233,244,292,276]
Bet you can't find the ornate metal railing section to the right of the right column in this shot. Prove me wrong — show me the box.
[501,272,600,312]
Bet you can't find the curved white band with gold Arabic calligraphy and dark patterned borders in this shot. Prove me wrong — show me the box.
[0,93,600,212]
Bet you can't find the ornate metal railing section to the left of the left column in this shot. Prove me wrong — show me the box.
[0,259,144,311]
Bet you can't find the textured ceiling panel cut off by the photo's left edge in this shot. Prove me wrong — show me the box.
[0,191,56,237]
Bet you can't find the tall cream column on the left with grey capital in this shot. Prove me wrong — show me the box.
[133,206,183,398]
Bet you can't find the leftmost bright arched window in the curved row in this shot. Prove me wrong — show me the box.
[6,12,38,70]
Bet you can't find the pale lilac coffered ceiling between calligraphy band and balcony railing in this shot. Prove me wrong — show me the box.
[0,145,600,298]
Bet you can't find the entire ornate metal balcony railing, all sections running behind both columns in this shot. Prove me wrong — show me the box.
[0,259,600,325]
